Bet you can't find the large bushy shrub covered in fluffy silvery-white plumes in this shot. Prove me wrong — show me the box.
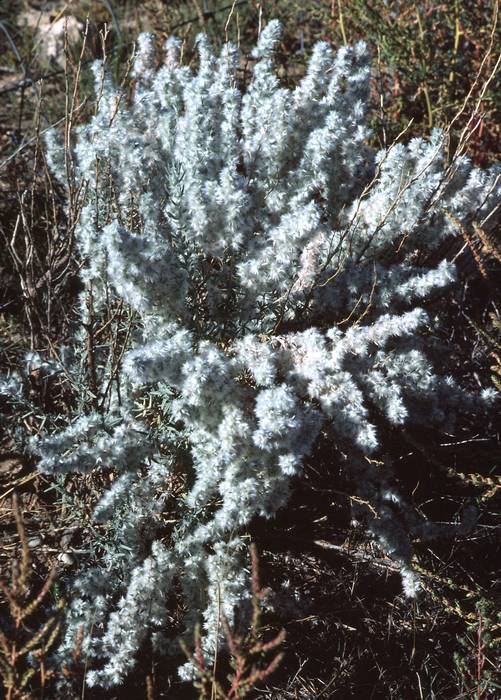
[1,21,501,687]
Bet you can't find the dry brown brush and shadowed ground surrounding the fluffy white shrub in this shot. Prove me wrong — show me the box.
[0,0,501,699]
